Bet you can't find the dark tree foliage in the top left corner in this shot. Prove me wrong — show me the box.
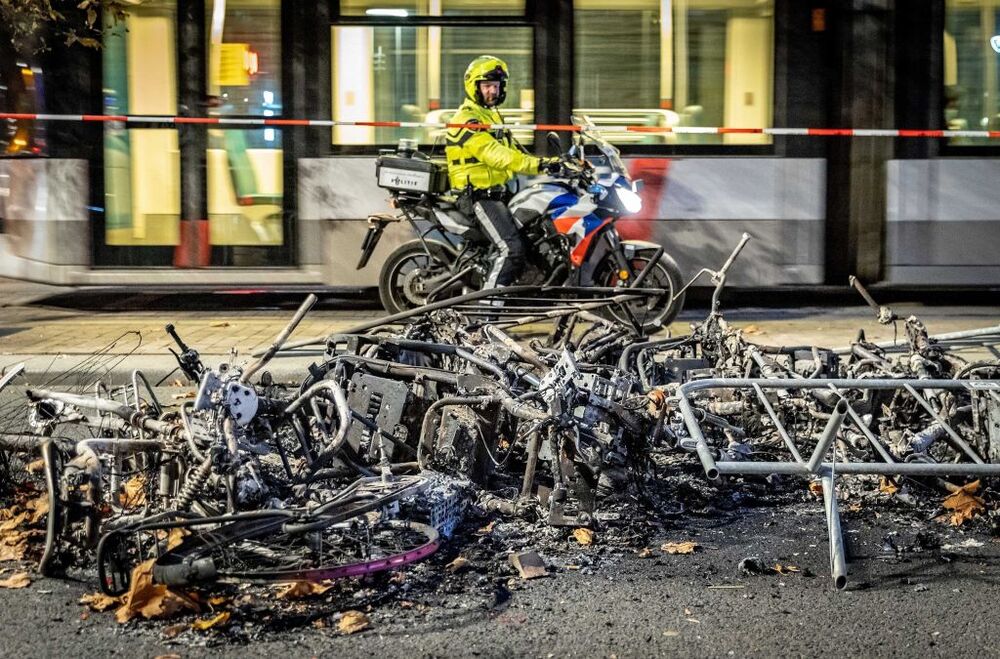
[0,0,128,53]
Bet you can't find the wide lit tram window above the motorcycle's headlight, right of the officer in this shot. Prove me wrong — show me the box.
[574,0,774,144]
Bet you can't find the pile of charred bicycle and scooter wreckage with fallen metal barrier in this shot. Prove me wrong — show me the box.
[0,235,1000,633]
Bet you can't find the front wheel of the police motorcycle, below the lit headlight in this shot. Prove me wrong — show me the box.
[596,249,685,335]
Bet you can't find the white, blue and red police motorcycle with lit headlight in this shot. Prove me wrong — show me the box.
[358,124,684,332]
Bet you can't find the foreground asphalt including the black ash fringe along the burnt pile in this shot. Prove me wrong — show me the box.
[0,465,1000,657]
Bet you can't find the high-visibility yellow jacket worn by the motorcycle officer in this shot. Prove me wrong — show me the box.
[444,99,538,189]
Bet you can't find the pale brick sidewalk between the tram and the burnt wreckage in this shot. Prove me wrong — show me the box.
[0,305,1000,380]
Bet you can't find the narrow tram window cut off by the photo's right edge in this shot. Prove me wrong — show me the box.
[943,0,1000,145]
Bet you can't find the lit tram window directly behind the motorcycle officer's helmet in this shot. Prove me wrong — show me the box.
[331,25,535,145]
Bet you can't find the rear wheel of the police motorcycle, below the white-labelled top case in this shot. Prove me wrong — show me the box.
[378,240,446,314]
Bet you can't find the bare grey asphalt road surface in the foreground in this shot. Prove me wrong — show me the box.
[0,502,1000,657]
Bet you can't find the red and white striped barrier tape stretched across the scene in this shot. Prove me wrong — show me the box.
[0,112,1000,138]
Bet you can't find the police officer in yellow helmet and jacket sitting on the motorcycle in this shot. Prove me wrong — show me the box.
[445,55,561,288]
